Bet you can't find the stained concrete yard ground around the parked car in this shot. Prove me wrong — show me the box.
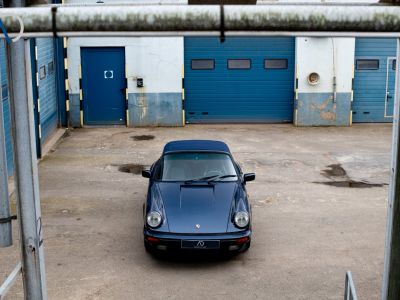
[0,124,391,299]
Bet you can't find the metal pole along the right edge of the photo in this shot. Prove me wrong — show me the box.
[382,39,400,300]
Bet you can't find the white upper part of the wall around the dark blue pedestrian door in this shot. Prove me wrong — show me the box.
[67,37,184,94]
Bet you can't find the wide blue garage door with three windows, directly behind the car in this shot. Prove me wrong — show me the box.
[185,37,295,123]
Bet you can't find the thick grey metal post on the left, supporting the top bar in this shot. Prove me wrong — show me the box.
[8,0,47,300]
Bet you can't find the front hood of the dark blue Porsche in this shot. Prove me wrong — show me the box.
[157,182,238,234]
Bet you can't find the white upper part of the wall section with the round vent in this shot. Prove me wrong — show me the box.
[296,37,355,93]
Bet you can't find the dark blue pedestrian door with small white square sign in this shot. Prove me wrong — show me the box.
[81,47,126,125]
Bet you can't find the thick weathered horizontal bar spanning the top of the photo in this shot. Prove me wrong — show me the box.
[0,4,400,36]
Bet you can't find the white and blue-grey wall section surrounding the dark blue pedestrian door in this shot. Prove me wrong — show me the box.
[67,37,183,127]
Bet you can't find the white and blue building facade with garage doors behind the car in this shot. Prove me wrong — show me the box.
[0,0,397,174]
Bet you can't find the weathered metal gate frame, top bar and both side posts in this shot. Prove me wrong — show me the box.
[0,4,400,300]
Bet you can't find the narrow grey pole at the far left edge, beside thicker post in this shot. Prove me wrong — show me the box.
[0,41,12,247]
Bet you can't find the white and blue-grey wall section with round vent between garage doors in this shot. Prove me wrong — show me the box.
[294,37,355,126]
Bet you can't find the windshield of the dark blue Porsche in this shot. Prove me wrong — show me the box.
[155,152,237,182]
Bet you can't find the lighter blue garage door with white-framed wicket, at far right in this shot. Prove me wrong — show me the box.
[352,38,397,122]
